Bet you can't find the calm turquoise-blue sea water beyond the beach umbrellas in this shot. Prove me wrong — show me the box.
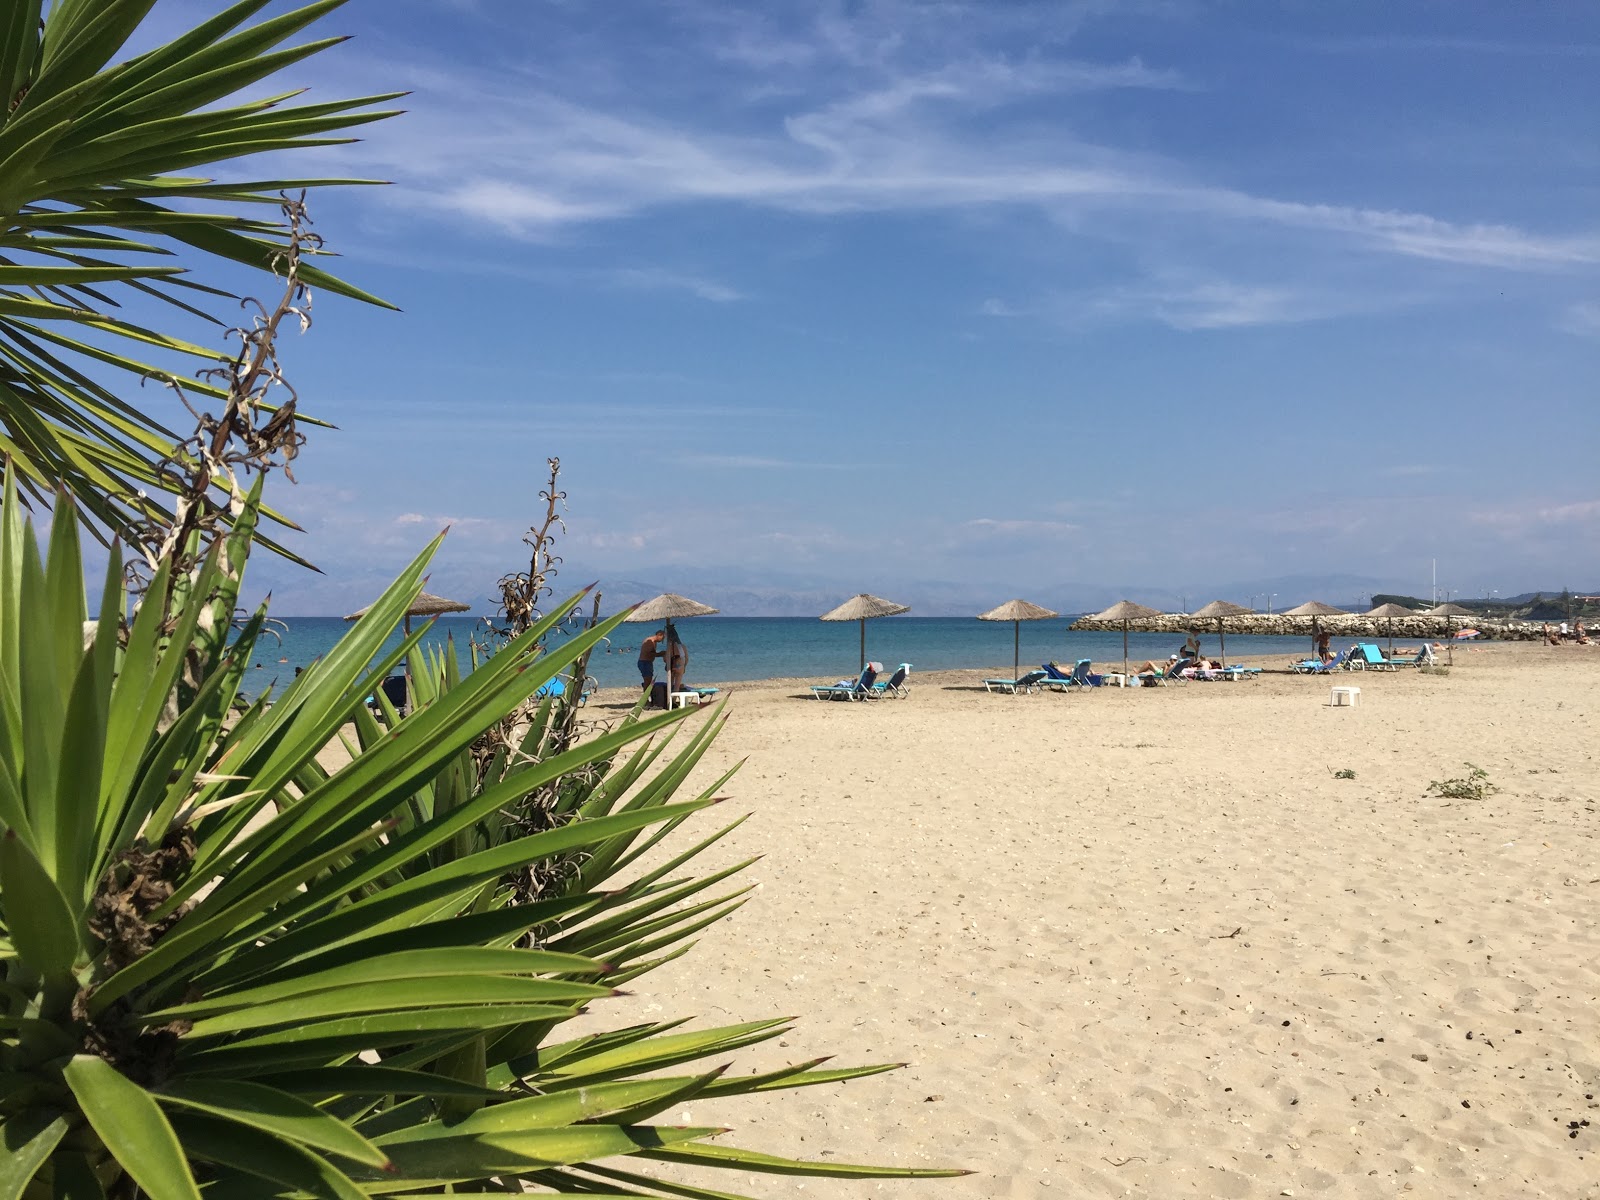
[233,616,1310,694]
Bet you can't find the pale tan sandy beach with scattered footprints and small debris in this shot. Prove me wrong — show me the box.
[582,645,1600,1200]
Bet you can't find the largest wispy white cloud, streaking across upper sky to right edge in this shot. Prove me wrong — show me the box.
[340,14,1600,275]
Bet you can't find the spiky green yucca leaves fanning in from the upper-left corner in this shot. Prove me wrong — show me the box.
[0,0,398,544]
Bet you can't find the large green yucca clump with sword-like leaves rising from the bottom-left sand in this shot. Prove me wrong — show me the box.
[0,478,960,1200]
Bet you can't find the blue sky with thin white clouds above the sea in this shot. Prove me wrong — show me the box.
[144,0,1600,613]
